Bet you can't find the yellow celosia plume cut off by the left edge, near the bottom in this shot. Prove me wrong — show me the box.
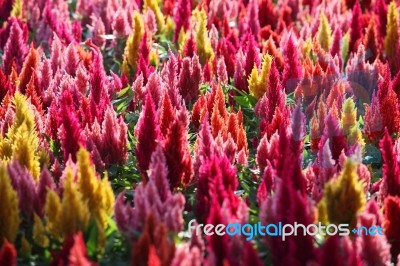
[0,162,21,246]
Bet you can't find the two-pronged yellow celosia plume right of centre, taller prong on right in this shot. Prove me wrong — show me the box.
[249,54,272,99]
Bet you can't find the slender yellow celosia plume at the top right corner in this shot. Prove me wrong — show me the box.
[385,1,399,57]
